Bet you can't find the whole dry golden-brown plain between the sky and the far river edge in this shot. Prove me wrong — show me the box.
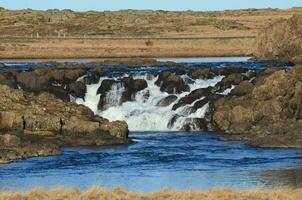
[0,8,302,59]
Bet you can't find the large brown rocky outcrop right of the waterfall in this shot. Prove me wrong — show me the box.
[213,66,302,147]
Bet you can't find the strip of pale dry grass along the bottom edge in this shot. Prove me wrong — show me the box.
[0,188,302,200]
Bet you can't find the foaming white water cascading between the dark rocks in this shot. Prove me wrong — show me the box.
[76,74,223,131]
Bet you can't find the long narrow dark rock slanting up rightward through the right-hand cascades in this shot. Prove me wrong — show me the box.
[172,87,212,110]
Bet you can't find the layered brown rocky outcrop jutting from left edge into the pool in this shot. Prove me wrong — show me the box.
[0,85,128,163]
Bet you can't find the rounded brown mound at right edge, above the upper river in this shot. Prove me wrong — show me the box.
[255,14,302,63]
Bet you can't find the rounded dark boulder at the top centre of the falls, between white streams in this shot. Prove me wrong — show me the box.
[155,71,190,94]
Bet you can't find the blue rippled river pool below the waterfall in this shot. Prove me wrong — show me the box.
[0,132,302,192]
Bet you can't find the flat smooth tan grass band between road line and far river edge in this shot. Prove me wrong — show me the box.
[0,36,255,59]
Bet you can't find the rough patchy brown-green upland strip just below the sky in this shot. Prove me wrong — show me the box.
[0,8,302,37]
